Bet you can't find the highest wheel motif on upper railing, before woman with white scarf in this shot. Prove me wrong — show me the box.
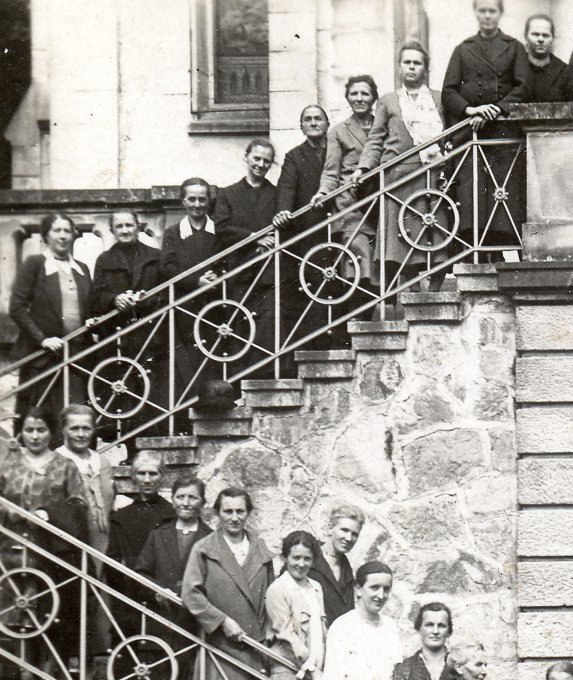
[398,189,460,252]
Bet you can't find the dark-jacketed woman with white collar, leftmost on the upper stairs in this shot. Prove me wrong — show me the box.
[10,213,91,428]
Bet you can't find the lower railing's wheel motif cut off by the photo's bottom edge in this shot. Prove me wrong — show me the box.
[107,635,179,680]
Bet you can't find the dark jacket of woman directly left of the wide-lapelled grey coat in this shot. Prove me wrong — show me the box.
[135,520,211,595]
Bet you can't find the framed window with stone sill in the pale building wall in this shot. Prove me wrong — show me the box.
[189,0,269,134]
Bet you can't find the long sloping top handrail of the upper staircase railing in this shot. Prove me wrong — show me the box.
[0,119,469,377]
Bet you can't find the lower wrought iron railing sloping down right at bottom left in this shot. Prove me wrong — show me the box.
[0,497,298,680]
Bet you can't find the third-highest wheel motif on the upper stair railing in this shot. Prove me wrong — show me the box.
[193,300,257,363]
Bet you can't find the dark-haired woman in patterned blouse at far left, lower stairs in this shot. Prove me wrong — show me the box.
[0,406,87,672]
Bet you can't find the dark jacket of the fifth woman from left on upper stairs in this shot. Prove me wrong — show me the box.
[277,141,326,243]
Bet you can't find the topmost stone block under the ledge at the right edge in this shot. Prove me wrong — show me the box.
[515,305,573,351]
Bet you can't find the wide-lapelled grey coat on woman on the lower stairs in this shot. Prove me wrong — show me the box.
[181,529,274,680]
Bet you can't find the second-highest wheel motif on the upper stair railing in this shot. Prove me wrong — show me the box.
[299,243,360,305]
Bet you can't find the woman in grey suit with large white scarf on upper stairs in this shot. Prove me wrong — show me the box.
[353,42,448,298]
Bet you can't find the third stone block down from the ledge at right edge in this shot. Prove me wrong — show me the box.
[516,406,573,454]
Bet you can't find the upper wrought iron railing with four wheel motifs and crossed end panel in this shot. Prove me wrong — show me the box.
[0,121,524,446]
